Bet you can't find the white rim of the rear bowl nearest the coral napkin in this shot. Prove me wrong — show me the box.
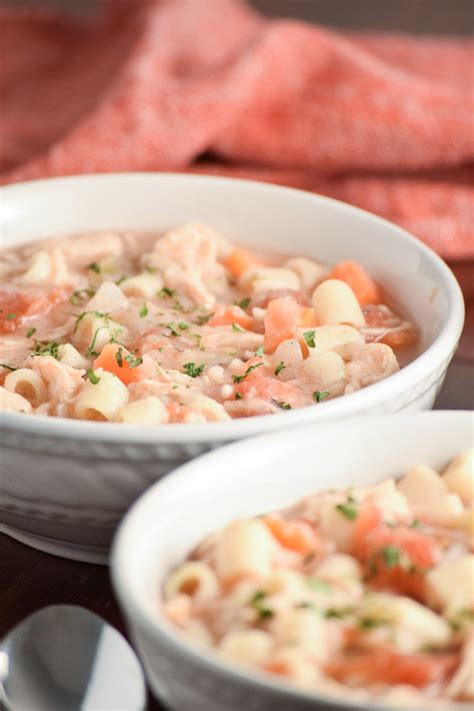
[1,173,464,443]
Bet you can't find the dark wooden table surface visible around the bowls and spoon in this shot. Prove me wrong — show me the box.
[0,262,474,711]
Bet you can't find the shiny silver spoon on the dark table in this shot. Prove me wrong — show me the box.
[0,605,146,711]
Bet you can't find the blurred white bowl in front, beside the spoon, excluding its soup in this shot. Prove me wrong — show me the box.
[112,412,474,711]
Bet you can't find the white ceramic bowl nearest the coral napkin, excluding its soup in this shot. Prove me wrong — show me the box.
[0,174,464,561]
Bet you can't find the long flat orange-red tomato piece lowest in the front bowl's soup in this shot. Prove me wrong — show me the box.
[325,648,459,689]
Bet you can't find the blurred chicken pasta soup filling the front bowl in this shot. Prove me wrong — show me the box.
[163,450,474,708]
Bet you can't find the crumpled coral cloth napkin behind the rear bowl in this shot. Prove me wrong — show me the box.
[0,0,474,259]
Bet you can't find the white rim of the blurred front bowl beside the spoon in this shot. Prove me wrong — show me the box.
[111,411,474,711]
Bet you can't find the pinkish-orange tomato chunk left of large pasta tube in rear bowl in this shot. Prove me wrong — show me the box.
[264,296,316,353]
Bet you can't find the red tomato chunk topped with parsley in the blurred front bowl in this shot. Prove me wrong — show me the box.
[353,503,439,599]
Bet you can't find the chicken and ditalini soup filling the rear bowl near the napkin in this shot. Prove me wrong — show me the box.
[0,224,417,425]
